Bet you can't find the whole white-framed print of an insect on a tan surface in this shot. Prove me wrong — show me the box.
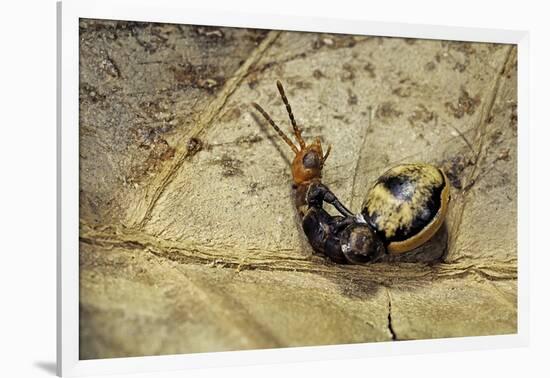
[58,1,528,375]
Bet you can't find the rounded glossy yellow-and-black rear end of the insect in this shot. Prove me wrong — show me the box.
[362,164,450,253]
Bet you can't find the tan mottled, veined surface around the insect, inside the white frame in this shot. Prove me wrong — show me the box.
[80,20,517,359]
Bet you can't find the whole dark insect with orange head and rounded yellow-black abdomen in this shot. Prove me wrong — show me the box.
[252,81,450,264]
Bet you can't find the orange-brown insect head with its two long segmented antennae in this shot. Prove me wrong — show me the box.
[252,81,331,185]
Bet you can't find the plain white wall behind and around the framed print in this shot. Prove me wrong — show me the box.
[0,0,550,378]
